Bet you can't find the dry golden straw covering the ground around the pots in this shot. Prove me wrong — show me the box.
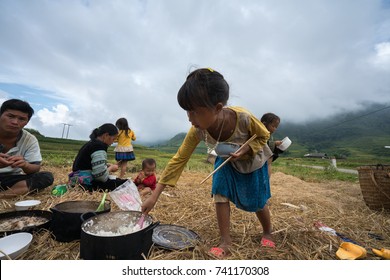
[0,168,390,260]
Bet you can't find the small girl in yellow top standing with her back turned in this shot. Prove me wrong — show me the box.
[114,118,136,178]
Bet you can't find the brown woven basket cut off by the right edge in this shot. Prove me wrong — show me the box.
[358,164,390,210]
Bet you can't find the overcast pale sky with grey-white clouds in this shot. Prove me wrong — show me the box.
[0,0,390,142]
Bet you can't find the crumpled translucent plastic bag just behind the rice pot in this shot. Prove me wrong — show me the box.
[110,180,142,211]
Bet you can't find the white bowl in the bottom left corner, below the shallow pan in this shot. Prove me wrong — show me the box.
[0,232,33,260]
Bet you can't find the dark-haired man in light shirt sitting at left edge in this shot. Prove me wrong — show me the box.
[0,99,54,198]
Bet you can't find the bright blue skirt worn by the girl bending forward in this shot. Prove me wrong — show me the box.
[211,157,271,212]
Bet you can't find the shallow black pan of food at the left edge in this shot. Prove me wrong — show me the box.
[0,210,52,236]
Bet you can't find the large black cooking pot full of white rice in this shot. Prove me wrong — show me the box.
[80,211,159,260]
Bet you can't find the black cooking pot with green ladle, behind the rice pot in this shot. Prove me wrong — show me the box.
[50,200,111,242]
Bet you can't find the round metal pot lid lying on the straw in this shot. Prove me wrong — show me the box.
[152,224,200,250]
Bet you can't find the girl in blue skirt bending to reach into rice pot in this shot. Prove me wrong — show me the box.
[142,68,275,258]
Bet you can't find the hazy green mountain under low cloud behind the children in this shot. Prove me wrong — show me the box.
[152,104,390,162]
